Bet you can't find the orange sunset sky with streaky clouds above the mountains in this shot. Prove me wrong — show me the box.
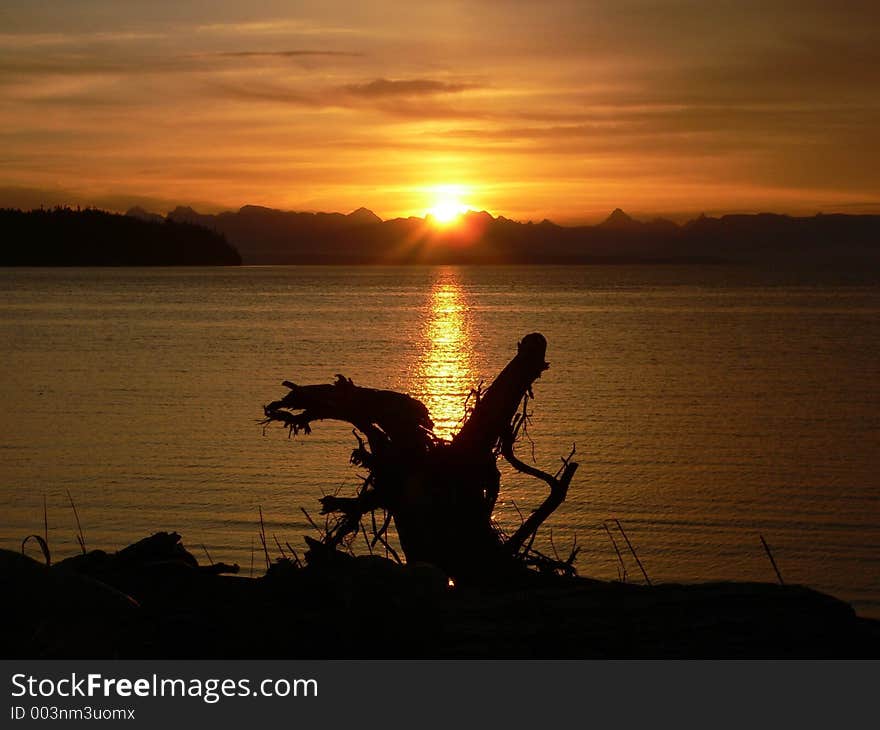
[0,0,880,223]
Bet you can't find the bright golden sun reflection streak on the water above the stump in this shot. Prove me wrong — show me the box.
[413,269,476,439]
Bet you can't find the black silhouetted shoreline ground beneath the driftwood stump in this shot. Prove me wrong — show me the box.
[0,533,880,659]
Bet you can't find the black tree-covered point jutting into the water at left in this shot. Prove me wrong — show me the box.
[0,208,241,266]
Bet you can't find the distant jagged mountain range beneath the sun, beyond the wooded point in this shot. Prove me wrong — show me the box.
[151,205,880,266]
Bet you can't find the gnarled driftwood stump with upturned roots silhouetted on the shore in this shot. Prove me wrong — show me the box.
[263,333,578,580]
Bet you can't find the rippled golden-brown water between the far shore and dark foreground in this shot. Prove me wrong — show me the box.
[0,267,880,616]
